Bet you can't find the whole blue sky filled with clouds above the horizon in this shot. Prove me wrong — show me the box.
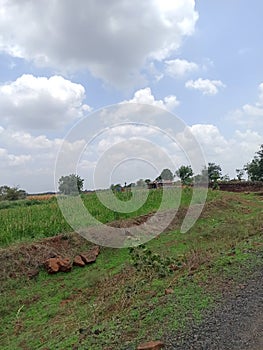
[0,0,263,193]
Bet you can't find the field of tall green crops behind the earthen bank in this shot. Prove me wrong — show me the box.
[0,188,220,247]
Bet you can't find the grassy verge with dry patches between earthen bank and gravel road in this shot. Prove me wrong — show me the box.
[0,191,263,350]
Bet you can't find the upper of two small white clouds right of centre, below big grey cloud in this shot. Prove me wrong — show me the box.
[165,59,199,78]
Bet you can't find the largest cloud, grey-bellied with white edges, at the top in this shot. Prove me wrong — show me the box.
[0,0,198,85]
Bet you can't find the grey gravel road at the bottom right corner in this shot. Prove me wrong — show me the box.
[165,262,263,350]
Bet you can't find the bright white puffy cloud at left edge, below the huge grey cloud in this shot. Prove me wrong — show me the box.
[0,74,91,130]
